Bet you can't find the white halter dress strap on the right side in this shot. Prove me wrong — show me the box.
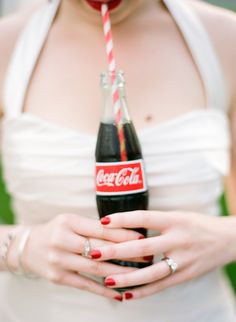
[163,0,229,111]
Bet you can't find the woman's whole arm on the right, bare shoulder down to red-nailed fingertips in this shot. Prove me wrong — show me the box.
[89,7,236,299]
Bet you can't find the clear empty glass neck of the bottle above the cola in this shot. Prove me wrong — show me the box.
[101,72,131,124]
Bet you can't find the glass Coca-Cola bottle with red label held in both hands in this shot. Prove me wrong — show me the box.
[96,71,148,268]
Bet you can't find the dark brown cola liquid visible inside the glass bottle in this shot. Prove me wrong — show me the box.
[96,122,150,268]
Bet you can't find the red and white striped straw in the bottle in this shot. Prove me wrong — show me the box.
[101,3,127,161]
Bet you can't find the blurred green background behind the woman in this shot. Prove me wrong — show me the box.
[0,0,236,293]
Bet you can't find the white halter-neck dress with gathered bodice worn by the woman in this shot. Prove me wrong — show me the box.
[0,0,236,322]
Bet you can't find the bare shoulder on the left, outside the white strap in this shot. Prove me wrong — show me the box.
[0,0,44,117]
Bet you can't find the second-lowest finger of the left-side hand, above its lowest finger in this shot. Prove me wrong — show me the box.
[59,253,136,277]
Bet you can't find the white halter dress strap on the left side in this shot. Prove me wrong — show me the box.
[3,0,60,117]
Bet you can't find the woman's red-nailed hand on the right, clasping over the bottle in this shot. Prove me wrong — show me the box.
[88,211,235,299]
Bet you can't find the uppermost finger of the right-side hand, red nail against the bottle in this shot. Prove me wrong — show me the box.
[101,210,175,231]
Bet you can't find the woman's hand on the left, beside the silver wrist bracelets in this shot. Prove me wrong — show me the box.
[9,214,144,300]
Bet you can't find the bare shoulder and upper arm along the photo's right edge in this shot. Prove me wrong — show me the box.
[190,0,236,215]
